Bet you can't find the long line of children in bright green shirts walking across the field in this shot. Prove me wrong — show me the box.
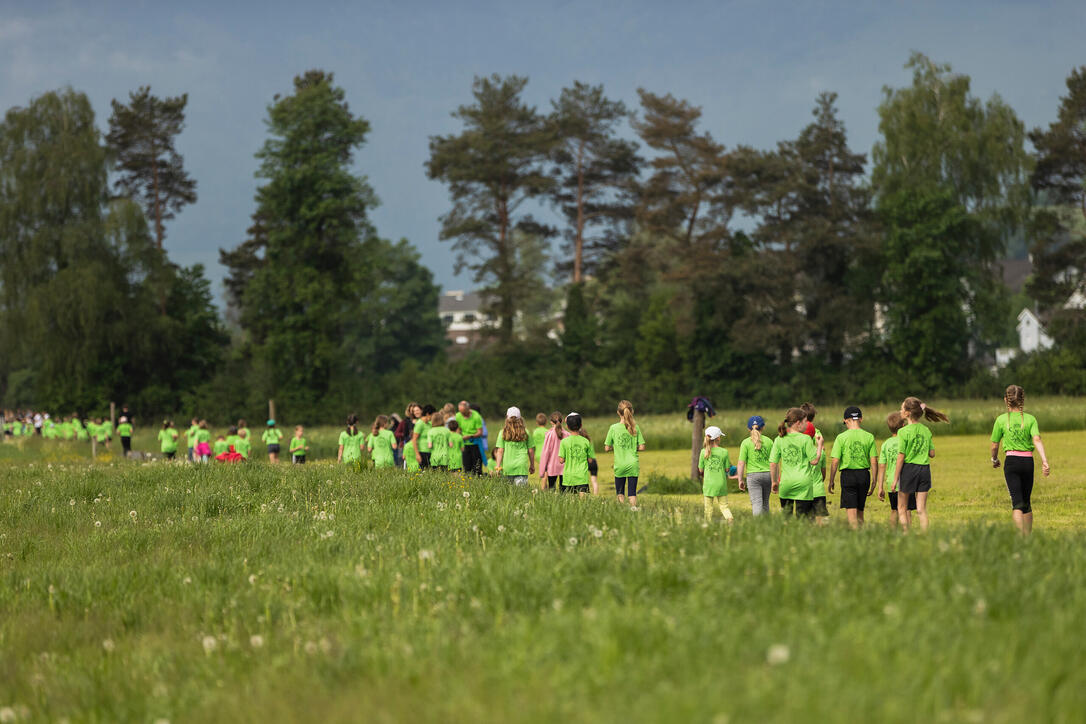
[3,385,1050,534]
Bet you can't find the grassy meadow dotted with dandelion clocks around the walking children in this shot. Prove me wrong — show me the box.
[0,433,1086,722]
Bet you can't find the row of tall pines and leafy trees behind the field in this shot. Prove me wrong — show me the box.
[0,53,1086,419]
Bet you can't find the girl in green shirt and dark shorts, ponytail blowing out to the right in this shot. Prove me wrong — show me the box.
[894,397,950,532]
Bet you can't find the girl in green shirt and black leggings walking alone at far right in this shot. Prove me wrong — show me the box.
[990,384,1051,535]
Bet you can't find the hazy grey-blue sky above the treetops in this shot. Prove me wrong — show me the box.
[0,0,1086,303]
